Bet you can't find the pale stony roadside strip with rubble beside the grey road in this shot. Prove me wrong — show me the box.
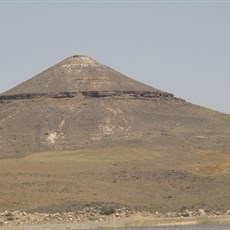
[0,209,230,230]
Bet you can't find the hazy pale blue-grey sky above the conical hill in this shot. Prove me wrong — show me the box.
[0,0,230,114]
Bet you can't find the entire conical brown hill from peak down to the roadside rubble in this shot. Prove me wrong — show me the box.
[0,55,230,212]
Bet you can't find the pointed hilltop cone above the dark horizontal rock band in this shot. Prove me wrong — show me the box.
[0,55,164,95]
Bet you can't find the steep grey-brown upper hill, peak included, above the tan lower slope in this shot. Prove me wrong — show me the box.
[0,55,230,155]
